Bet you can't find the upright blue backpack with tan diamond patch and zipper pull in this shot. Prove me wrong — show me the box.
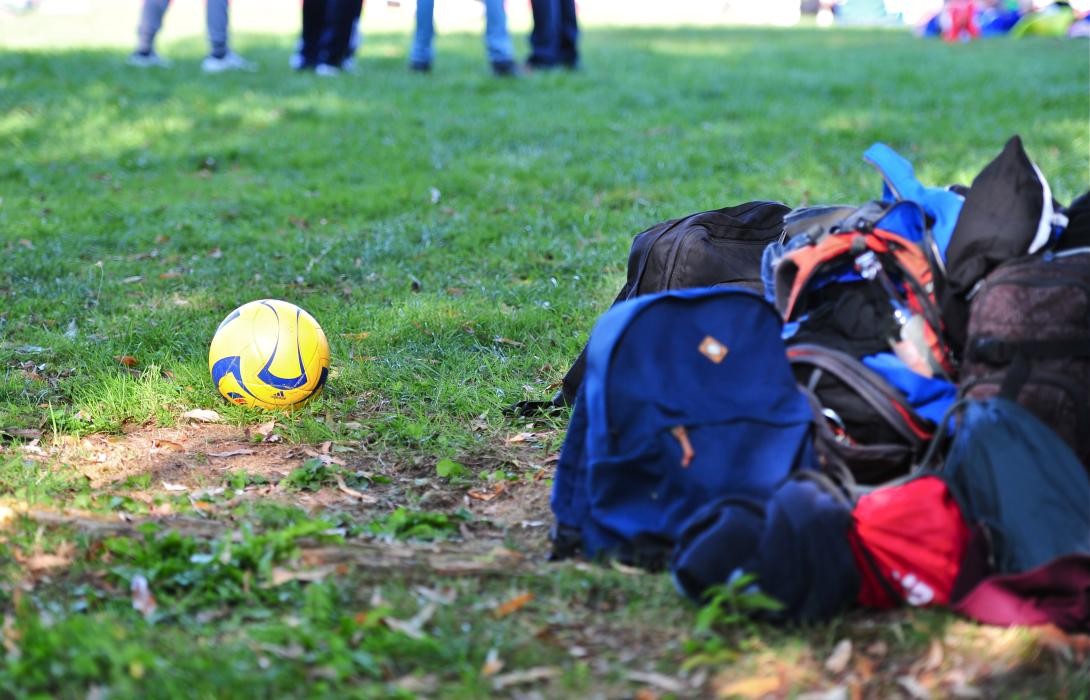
[552,288,813,568]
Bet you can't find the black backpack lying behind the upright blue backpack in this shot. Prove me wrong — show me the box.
[545,202,790,411]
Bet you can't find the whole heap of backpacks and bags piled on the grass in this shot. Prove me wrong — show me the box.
[552,136,1090,629]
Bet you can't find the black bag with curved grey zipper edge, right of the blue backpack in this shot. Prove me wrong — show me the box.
[787,343,935,485]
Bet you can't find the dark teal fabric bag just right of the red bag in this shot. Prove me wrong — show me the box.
[943,398,1090,574]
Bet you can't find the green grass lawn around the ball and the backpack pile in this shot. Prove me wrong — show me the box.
[0,17,1090,698]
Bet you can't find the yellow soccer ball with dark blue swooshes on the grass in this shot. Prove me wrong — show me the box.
[208,299,329,409]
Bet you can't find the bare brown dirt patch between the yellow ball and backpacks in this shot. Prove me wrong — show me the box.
[10,423,556,558]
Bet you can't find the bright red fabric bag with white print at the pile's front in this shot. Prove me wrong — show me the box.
[848,475,970,608]
